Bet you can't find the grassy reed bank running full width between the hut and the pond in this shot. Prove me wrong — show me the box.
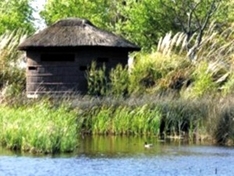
[0,96,234,153]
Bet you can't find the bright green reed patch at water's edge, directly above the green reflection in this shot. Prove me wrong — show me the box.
[77,105,160,135]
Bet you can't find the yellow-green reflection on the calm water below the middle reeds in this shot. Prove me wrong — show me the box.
[78,136,163,157]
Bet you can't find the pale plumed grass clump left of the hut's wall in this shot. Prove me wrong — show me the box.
[0,30,27,96]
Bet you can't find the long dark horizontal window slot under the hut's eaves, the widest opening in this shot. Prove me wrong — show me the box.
[41,53,75,62]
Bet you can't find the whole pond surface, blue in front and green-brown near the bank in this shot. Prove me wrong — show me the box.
[0,136,234,176]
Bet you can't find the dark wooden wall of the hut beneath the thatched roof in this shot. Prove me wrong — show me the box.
[26,49,128,95]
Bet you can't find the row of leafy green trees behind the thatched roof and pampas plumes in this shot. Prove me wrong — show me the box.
[41,0,233,51]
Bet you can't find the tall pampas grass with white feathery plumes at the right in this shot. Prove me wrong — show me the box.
[156,23,234,97]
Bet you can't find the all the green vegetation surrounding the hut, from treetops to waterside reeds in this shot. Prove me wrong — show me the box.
[0,0,234,153]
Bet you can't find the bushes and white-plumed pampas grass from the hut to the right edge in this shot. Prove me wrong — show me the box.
[85,23,234,97]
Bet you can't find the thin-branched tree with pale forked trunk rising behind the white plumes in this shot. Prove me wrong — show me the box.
[160,0,231,59]
